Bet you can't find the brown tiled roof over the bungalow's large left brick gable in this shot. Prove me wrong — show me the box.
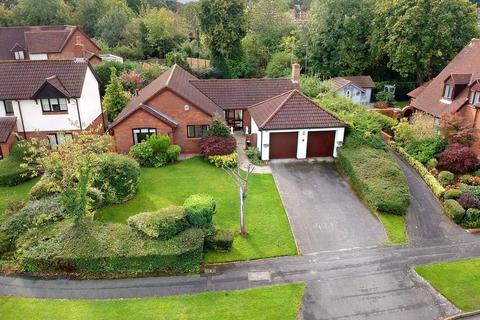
[110,65,222,128]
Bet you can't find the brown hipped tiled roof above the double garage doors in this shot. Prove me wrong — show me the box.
[248,90,346,130]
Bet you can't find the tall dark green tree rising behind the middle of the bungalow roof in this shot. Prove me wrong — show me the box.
[199,0,246,78]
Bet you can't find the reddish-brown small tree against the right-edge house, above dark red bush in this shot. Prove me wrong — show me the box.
[440,113,475,147]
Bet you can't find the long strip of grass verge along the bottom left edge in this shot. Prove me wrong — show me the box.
[0,283,304,320]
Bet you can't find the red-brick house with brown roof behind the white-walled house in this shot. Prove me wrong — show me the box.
[0,25,101,64]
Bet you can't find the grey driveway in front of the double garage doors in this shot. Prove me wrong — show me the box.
[270,161,386,254]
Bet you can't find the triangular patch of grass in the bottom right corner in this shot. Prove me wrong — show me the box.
[415,259,480,311]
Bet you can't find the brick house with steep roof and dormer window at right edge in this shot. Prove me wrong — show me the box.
[408,39,480,155]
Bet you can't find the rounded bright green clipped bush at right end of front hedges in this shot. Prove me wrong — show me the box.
[183,194,217,227]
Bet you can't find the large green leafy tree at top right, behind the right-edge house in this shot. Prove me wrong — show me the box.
[371,0,478,83]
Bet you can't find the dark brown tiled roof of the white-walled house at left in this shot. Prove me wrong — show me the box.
[0,60,89,100]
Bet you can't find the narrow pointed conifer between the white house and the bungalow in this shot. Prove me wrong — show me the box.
[102,67,128,121]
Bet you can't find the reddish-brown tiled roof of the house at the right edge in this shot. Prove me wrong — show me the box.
[411,39,480,117]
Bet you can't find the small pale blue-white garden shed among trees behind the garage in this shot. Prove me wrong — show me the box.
[332,76,375,104]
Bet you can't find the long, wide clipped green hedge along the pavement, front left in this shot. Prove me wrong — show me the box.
[19,220,204,274]
